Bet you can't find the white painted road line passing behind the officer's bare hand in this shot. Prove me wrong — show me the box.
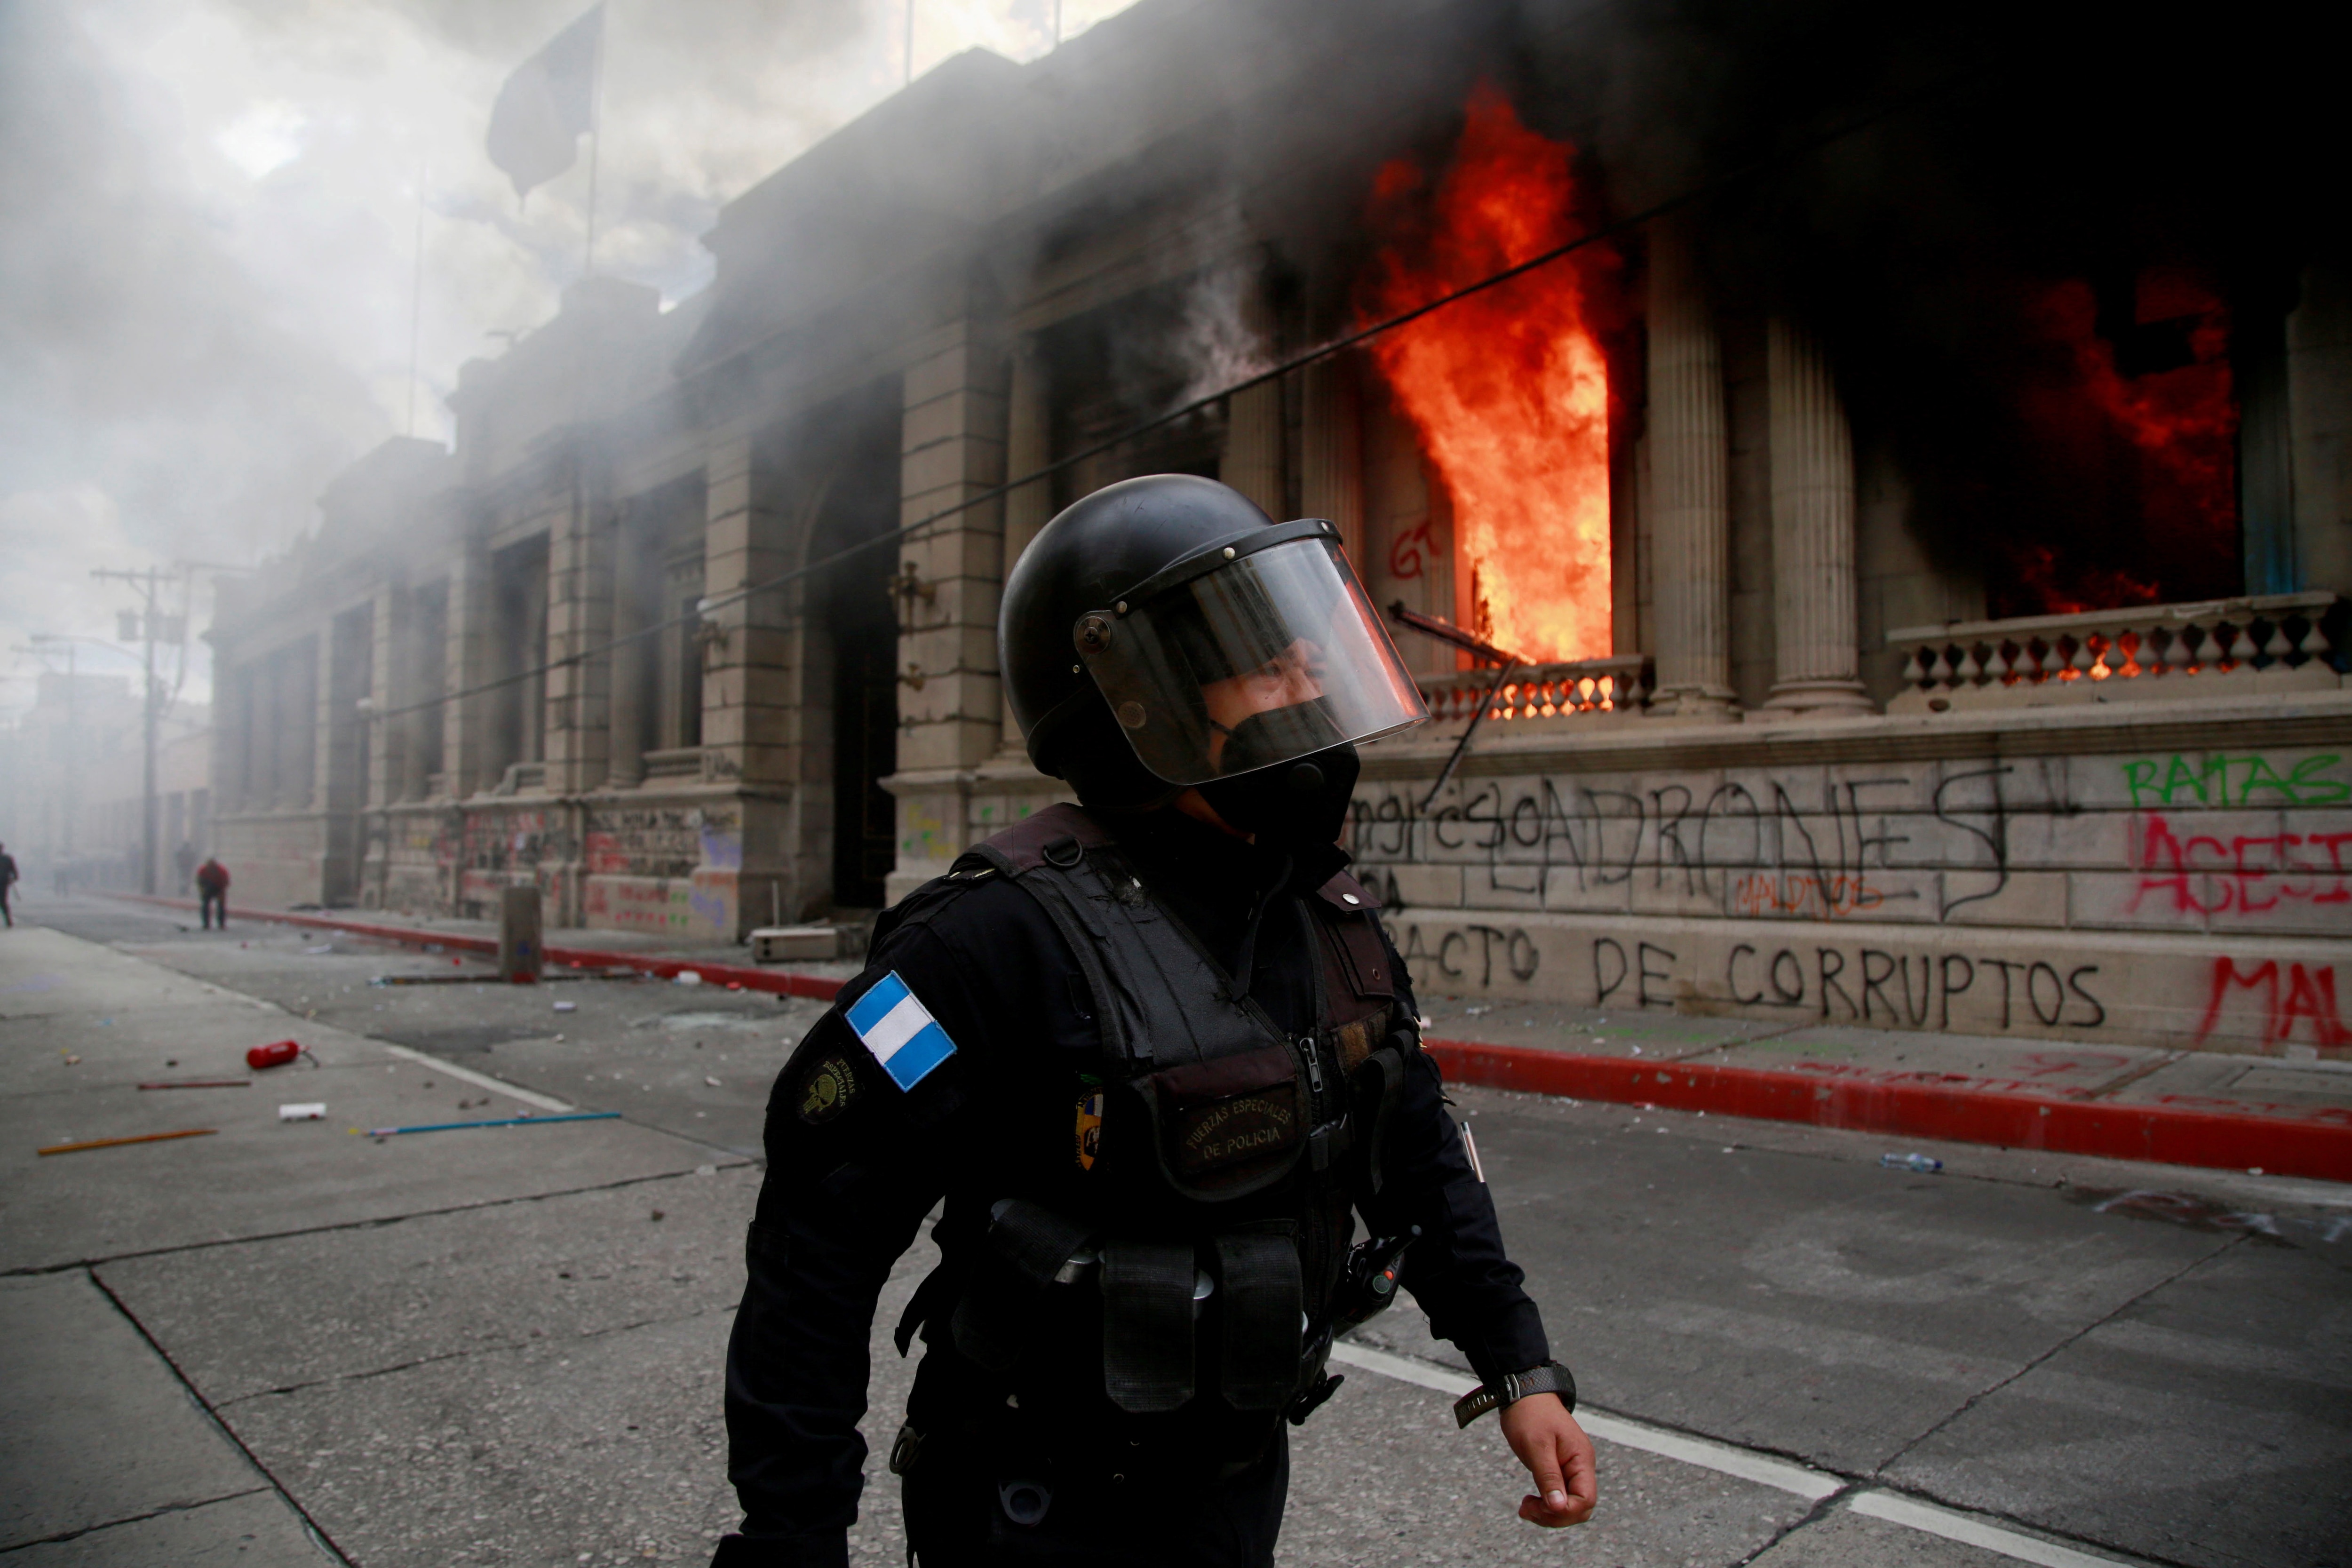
[1331,1340,2140,1568]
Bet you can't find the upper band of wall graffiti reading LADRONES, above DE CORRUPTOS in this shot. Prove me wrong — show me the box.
[1348,752,2352,933]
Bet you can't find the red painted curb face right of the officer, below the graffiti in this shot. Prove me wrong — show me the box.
[1423,1039,2352,1182]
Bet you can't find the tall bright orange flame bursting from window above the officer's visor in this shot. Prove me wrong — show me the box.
[1367,87,1613,658]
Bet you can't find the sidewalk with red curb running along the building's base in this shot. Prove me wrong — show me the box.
[106,898,2352,1182]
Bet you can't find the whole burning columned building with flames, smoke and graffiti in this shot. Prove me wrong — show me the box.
[214,0,2352,1053]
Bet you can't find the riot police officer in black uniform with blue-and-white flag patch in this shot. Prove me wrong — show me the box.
[717,475,1595,1568]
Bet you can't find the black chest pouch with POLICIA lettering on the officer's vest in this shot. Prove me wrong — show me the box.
[1134,1044,1308,1203]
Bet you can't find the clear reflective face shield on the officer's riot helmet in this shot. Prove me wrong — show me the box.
[1073,519,1430,785]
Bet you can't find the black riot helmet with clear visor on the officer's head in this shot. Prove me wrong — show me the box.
[997,475,1428,830]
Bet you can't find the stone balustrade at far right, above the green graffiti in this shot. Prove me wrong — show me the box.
[1886,592,2345,712]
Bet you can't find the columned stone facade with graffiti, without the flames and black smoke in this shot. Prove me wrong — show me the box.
[214,0,2352,1056]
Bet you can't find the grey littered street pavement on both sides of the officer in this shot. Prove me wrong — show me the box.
[0,900,2352,1568]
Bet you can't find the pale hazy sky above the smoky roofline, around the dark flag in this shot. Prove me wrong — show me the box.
[0,0,1131,722]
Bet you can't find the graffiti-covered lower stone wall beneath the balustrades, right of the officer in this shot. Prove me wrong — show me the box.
[1348,710,2352,1056]
